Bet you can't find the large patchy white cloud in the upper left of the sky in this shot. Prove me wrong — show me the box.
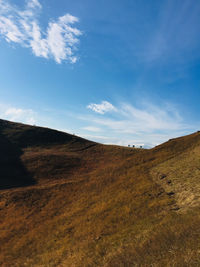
[0,0,82,63]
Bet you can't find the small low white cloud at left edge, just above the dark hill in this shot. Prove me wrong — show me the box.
[0,104,36,124]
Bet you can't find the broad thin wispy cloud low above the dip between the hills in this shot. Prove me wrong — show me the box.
[84,100,195,147]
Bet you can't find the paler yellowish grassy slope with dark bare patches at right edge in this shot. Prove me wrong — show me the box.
[151,138,200,212]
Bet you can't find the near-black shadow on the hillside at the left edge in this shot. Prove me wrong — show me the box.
[0,133,35,190]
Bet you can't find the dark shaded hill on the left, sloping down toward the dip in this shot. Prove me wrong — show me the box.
[0,120,95,189]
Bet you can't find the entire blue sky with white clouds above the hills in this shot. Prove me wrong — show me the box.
[0,0,200,147]
